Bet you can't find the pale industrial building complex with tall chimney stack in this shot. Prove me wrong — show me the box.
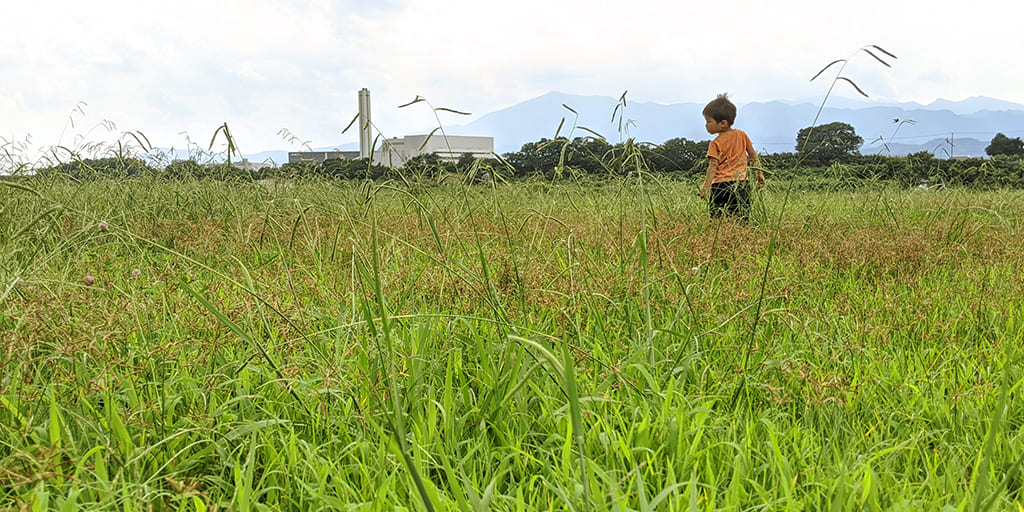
[288,89,495,167]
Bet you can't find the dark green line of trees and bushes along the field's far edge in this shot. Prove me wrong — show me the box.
[16,123,1024,187]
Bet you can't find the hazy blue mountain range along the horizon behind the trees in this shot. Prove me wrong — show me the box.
[246,92,1024,164]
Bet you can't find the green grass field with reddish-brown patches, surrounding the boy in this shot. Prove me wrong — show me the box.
[0,174,1024,511]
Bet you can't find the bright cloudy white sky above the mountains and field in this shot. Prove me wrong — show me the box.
[0,0,1024,161]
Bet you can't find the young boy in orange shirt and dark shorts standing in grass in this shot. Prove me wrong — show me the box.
[700,94,765,220]
